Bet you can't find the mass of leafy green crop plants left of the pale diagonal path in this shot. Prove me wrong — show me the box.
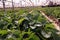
[0,10,60,40]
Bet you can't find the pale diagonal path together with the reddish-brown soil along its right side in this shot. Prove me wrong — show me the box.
[40,11,60,31]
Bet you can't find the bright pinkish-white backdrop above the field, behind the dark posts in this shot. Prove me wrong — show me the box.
[0,0,60,7]
